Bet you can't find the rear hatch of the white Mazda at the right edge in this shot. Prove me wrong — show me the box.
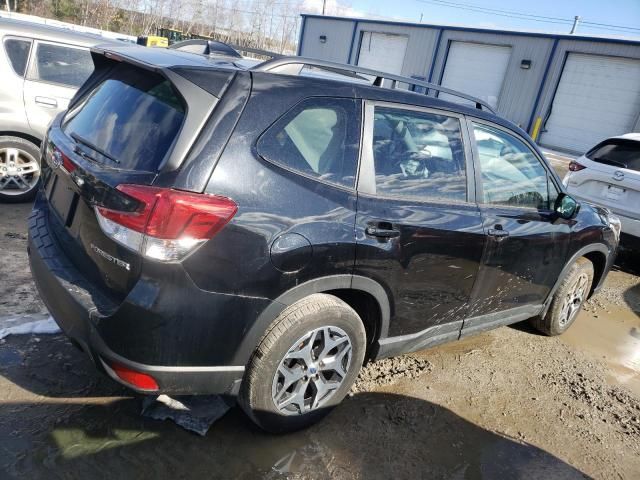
[569,138,640,218]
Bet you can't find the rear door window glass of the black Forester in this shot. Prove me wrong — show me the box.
[373,107,467,201]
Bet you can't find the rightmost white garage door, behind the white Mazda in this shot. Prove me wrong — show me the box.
[540,53,640,153]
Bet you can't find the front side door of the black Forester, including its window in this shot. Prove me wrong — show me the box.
[465,120,573,322]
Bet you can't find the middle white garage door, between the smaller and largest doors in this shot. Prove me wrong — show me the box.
[439,42,511,107]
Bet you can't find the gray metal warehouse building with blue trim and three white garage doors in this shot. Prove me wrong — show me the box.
[298,15,640,153]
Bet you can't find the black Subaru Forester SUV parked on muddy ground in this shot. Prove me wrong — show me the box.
[29,46,619,431]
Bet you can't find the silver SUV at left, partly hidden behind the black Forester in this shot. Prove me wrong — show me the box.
[0,18,116,202]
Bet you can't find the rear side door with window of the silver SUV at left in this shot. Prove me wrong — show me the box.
[24,40,93,133]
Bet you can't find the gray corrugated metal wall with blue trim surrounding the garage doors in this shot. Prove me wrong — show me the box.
[300,17,640,148]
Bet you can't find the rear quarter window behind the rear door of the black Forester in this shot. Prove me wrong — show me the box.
[257,98,360,187]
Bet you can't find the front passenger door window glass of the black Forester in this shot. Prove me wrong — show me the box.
[473,123,558,210]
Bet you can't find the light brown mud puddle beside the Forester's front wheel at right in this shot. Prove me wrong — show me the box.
[559,307,640,397]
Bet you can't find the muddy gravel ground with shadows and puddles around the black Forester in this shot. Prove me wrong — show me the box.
[0,189,640,479]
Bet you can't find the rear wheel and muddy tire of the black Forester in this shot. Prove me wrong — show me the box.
[239,294,366,433]
